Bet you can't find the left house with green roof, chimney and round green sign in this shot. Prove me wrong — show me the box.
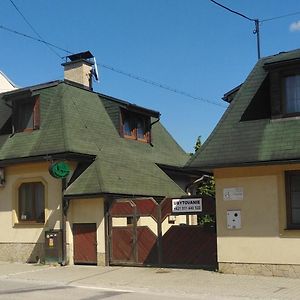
[0,52,191,265]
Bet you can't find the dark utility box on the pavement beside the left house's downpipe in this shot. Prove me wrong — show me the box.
[45,229,62,265]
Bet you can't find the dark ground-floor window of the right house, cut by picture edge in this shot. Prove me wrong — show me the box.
[285,171,300,229]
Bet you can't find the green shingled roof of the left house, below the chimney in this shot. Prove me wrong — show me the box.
[0,82,189,197]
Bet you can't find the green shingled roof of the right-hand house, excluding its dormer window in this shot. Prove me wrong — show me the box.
[187,50,300,170]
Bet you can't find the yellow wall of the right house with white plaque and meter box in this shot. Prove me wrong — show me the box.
[214,164,300,264]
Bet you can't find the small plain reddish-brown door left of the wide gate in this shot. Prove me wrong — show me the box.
[73,223,97,265]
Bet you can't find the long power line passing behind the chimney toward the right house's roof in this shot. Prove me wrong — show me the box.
[0,25,227,108]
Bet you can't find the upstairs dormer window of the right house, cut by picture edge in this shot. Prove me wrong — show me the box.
[283,75,300,114]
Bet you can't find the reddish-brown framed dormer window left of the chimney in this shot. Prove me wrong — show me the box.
[13,97,40,132]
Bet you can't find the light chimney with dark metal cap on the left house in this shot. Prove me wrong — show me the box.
[62,51,94,90]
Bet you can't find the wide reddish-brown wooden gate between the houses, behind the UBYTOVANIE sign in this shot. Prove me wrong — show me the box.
[109,197,217,268]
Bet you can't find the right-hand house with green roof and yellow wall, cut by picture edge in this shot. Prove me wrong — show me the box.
[188,50,300,277]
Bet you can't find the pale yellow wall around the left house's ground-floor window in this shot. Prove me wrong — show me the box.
[0,162,62,243]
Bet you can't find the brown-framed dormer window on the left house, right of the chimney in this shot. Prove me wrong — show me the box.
[121,110,150,143]
